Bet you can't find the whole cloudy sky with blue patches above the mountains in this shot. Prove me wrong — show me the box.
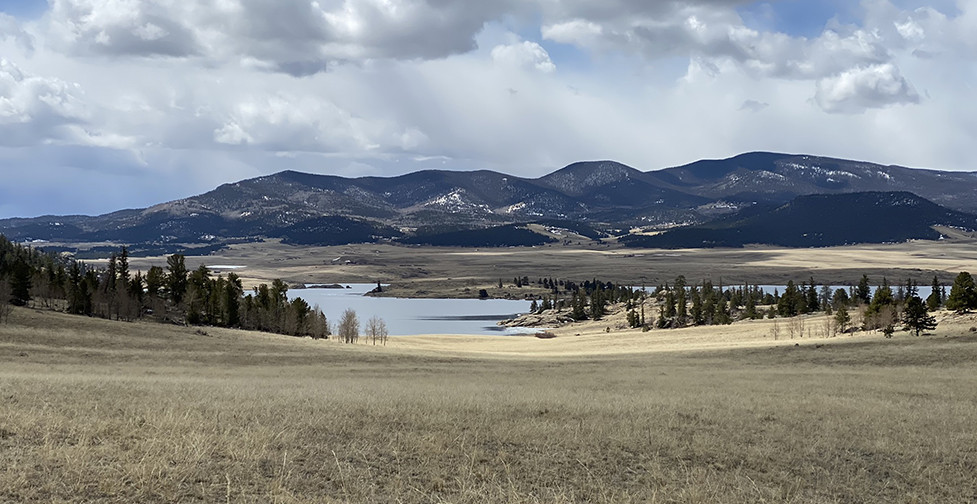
[0,0,977,218]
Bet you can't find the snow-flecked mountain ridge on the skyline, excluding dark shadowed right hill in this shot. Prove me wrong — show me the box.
[0,152,977,250]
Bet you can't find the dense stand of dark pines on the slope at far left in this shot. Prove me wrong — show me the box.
[0,235,329,338]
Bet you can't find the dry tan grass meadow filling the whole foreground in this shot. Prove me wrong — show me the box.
[0,310,977,503]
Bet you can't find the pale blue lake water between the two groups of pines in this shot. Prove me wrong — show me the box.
[288,284,531,336]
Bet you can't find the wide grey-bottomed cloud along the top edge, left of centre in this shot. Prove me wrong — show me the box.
[42,0,507,76]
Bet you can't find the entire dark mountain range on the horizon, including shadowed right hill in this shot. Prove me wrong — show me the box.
[0,152,977,249]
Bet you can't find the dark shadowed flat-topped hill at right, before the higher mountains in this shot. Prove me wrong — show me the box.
[622,192,977,248]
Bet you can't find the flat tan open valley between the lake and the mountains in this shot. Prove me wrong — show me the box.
[122,236,977,298]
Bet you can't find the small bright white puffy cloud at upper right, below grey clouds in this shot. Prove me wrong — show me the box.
[814,63,919,113]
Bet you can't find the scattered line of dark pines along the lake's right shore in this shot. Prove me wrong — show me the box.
[520,272,977,337]
